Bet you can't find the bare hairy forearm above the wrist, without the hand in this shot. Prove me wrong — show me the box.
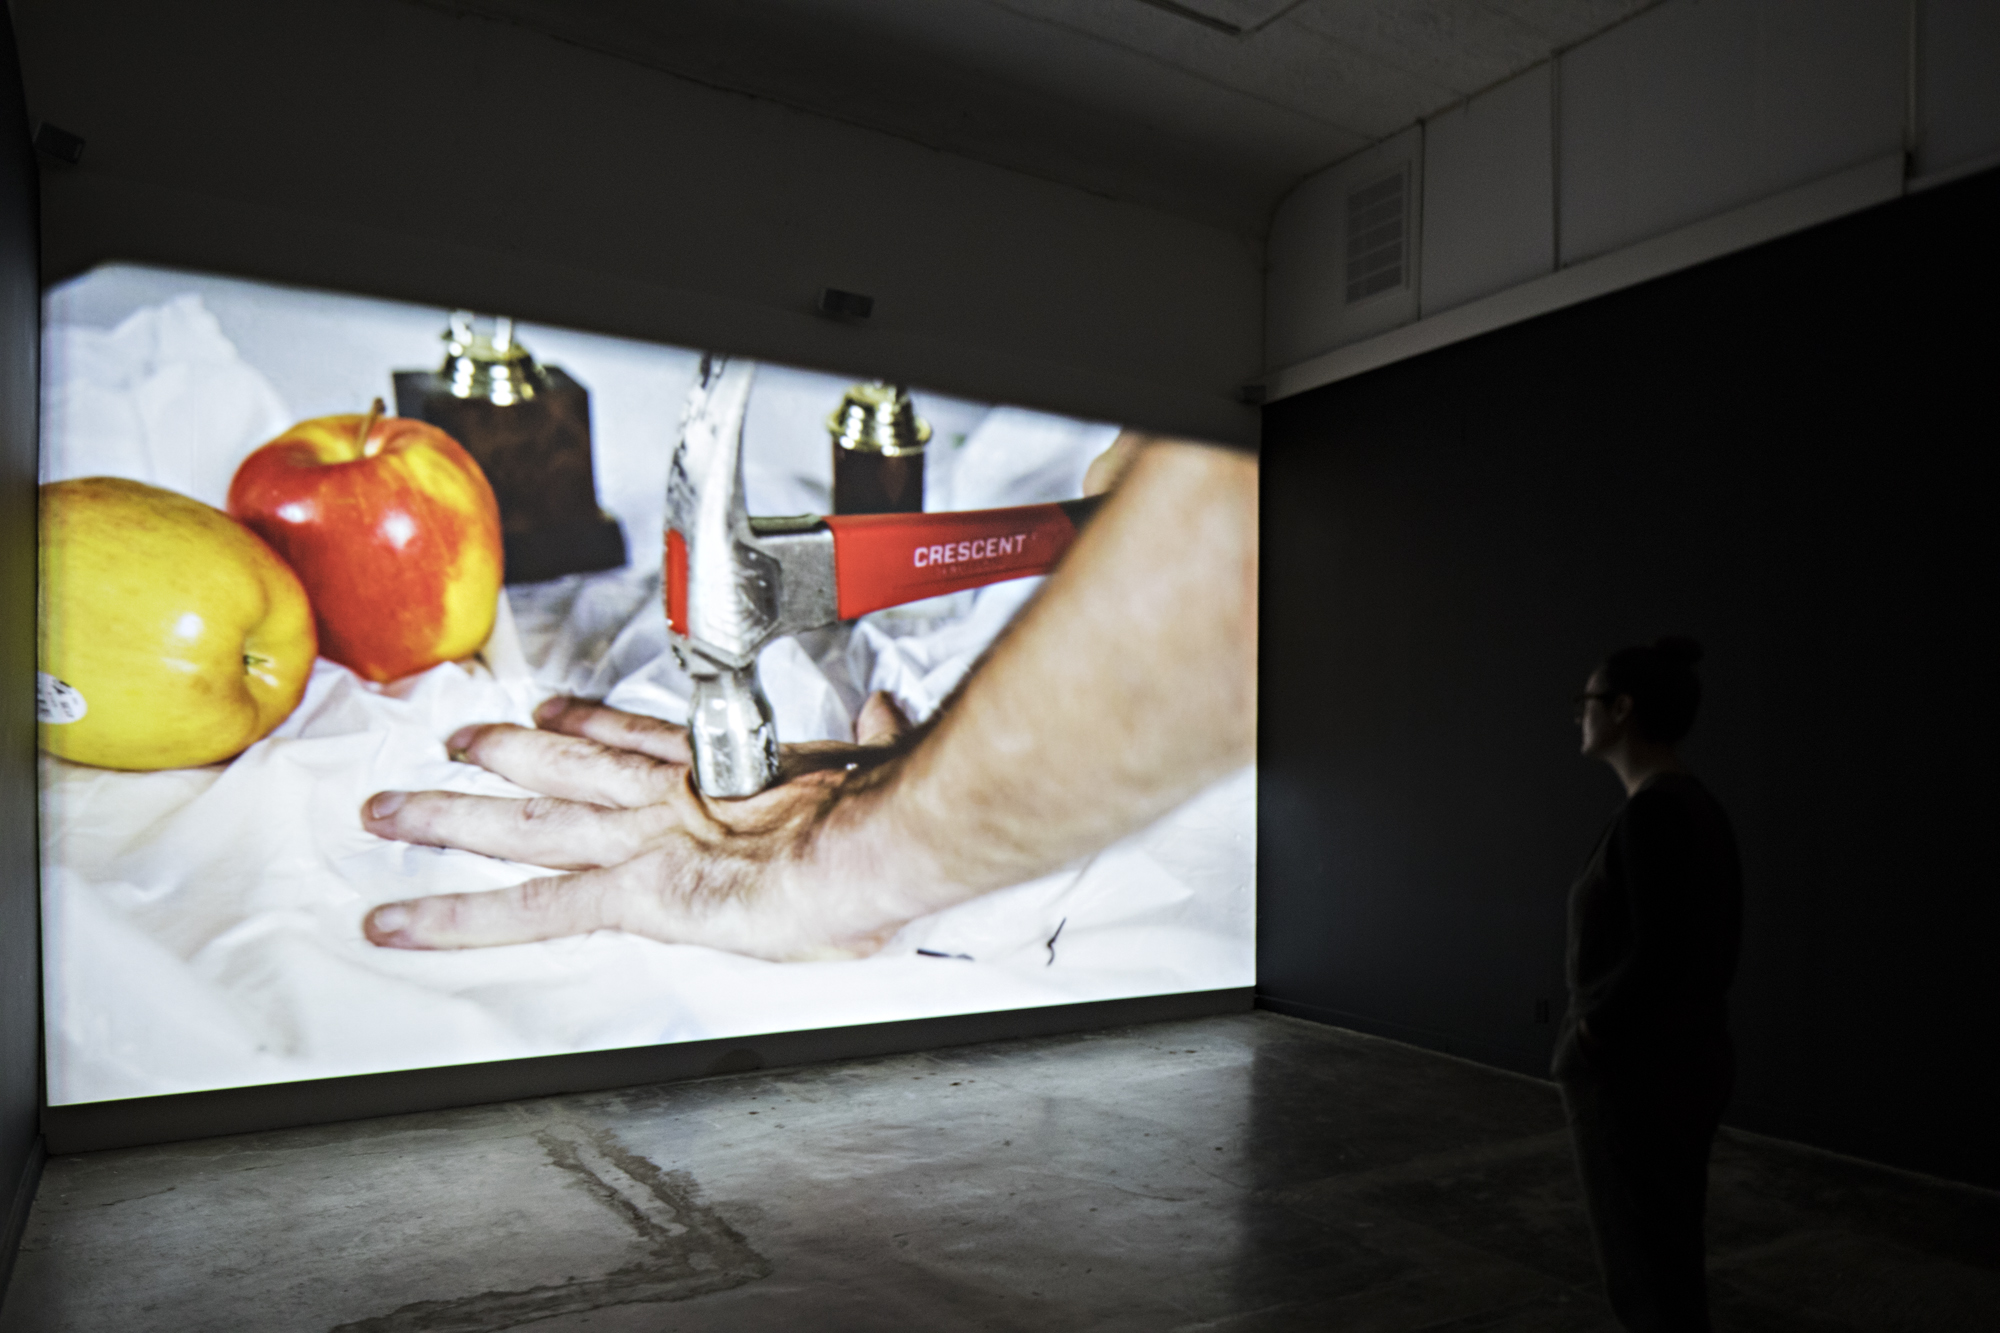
[828,440,1258,911]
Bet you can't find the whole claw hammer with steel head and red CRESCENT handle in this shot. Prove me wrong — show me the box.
[666,356,1098,797]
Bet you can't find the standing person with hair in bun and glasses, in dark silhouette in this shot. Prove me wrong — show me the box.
[1554,638,1742,1333]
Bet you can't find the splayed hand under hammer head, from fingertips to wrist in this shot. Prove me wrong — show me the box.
[362,695,928,961]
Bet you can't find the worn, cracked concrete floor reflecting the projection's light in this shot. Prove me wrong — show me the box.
[0,1013,2000,1333]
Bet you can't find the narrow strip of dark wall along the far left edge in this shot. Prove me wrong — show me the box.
[0,5,42,1289]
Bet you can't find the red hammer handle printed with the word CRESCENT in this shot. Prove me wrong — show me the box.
[826,500,1096,620]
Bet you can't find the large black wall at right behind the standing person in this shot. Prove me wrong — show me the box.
[1258,172,2000,1185]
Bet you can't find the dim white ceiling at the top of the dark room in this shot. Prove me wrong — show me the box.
[420,0,1658,234]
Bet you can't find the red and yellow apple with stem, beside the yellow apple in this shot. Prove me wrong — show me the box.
[230,398,500,681]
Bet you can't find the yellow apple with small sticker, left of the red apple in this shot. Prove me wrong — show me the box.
[36,476,318,769]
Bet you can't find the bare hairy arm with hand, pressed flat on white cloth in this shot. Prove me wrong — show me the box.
[364,436,1258,959]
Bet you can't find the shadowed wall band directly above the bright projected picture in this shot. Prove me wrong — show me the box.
[12,0,1262,440]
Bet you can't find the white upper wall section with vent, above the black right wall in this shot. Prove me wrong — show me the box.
[1266,0,2000,382]
